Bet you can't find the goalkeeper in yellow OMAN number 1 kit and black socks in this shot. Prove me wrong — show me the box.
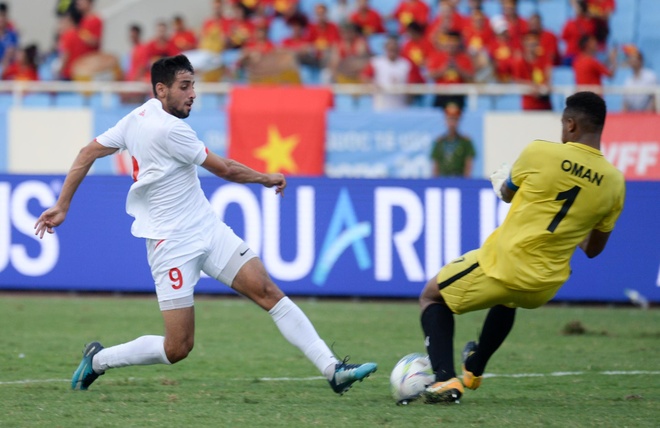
[420,92,625,403]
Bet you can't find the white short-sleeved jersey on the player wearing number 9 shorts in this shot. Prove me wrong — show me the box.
[96,99,215,239]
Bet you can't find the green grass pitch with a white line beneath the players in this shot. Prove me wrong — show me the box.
[0,294,660,428]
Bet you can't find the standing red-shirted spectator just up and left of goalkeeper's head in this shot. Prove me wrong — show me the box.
[512,33,552,110]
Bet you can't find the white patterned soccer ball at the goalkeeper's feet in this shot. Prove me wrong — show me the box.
[390,353,435,404]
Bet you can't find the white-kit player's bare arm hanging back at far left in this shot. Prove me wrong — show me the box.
[34,140,117,239]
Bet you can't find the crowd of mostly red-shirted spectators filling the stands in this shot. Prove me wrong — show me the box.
[0,0,655,110]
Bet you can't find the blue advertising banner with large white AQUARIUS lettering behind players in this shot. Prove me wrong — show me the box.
[0,175,660,302]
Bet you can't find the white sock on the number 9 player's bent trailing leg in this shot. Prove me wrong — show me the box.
[92,336,171,373]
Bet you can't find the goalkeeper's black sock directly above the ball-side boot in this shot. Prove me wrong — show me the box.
[422,303,456,382]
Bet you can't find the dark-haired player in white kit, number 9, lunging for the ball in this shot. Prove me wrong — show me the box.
[35,55,377,394]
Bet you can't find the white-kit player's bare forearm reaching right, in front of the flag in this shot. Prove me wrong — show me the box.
[202,152,286,196]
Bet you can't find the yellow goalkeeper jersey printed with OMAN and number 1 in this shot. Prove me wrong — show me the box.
[478,140,625,291]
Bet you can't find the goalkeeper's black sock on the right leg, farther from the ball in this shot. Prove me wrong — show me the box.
[465,305,516,376]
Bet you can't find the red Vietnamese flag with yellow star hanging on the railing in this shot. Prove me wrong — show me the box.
[228,87,332,175]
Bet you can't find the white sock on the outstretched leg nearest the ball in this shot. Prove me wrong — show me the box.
[268,297,338,380]
